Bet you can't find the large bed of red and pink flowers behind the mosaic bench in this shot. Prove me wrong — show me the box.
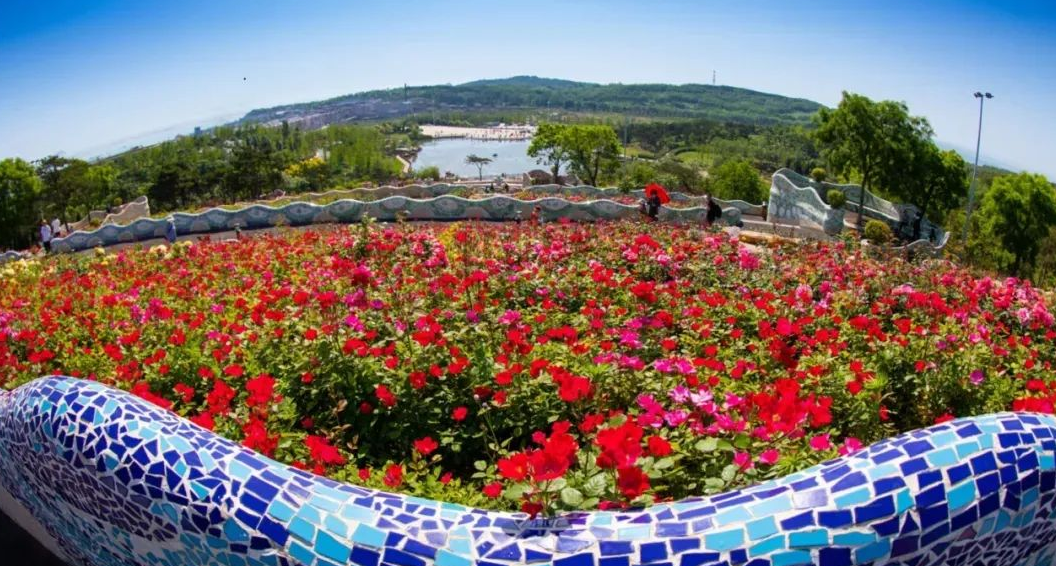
[0,223,1056,513]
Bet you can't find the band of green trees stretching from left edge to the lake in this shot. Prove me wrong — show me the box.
[0,124,403,248]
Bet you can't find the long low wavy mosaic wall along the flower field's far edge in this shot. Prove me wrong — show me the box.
[52,195,741,251]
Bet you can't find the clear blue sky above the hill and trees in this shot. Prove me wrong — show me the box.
[0,0,1056,178]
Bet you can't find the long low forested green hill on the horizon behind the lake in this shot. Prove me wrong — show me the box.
[240,76,821,129]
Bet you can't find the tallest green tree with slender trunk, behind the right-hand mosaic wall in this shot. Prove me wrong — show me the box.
[814,92,932,228]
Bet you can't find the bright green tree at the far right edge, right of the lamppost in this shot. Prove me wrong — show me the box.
[979,173,1056,277]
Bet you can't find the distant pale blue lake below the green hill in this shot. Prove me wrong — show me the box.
[413,137,545,178]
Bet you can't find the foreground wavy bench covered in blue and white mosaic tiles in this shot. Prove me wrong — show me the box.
[0,377,1056,566]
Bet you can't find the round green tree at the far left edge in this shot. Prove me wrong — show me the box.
[0,158,42,248]
